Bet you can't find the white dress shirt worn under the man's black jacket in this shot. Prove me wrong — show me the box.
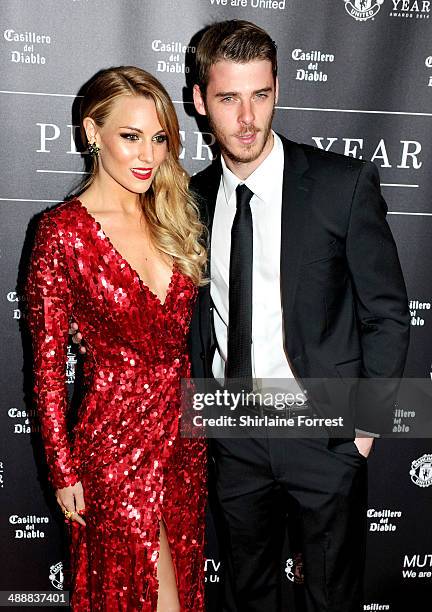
[210,132,294,379]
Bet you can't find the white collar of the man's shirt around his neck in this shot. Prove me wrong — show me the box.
[221,130,284,205]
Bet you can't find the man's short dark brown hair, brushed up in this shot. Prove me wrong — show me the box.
[196,19,277,94]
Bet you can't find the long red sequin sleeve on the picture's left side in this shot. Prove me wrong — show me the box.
[26,216,80,489]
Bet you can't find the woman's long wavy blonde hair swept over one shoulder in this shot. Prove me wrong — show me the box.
[79,66,207,285]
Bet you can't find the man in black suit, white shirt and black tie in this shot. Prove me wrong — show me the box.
[191,21,409,612]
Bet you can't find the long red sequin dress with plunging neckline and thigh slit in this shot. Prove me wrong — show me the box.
[27,199,206,612]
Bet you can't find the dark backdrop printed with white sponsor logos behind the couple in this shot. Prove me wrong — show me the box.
[0,0,432,612]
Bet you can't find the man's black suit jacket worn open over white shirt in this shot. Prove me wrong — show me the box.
[190,137,410,433]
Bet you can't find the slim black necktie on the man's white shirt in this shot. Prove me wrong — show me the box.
[225,185,253,391]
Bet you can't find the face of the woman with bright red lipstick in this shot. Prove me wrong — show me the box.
[84,95,168,194]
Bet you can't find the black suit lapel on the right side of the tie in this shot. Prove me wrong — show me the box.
[280,137,313,358]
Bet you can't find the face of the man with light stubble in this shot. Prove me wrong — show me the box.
[194,60,278,178]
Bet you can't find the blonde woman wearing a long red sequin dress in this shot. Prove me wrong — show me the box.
[27,67,206,612]
